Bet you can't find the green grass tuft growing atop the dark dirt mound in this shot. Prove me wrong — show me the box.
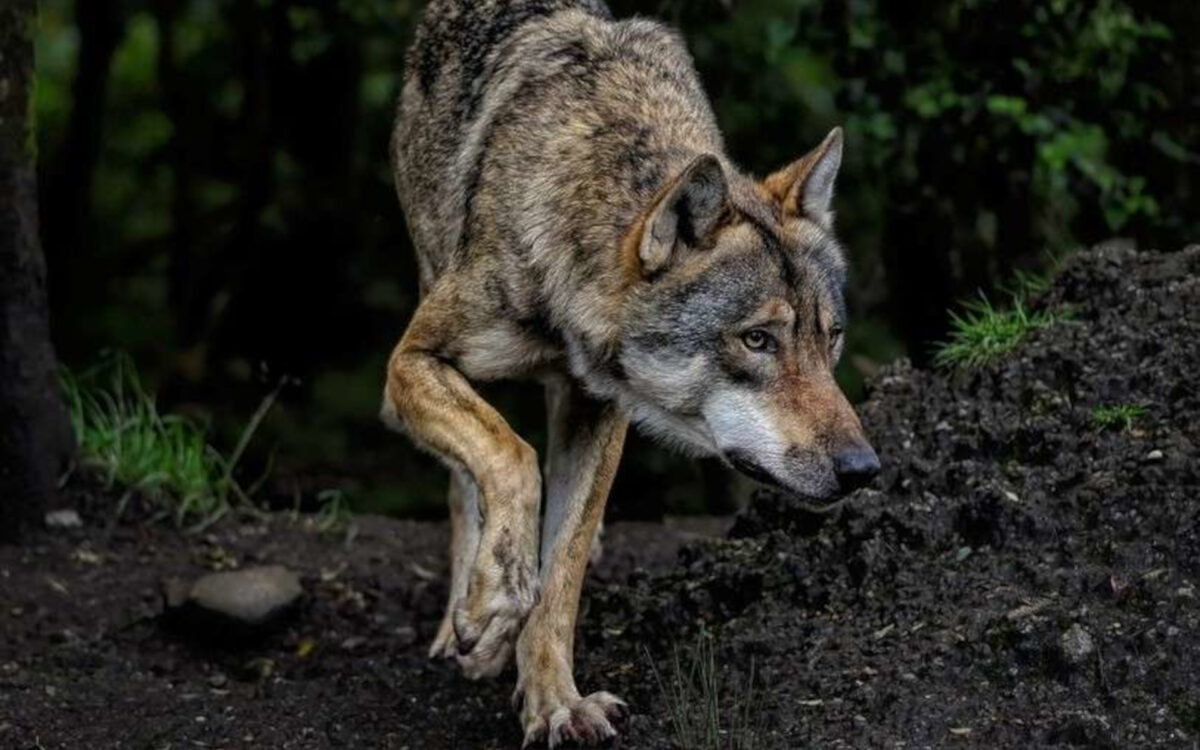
[934,292,1064,370]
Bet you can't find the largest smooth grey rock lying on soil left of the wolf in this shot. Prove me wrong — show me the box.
[164,565,304,640]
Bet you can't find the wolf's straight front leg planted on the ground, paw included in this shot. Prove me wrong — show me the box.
[515,382,626,748]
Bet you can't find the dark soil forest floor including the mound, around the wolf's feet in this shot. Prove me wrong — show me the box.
[0,246,1200,750]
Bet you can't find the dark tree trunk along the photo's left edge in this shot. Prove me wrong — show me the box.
[0,0,73,541]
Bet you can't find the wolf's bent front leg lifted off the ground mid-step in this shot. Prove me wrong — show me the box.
[384,298,541,679]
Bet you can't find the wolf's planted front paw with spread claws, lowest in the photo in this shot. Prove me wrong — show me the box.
[521,691,628,749]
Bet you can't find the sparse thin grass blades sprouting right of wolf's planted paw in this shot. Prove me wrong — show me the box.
[646,631,764,750]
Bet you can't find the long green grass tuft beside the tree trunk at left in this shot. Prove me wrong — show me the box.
[62,354,278,528]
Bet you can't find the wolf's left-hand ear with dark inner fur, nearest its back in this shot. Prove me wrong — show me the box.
[637,154,730,275]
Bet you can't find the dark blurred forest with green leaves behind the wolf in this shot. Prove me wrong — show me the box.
[36,0,1200,516]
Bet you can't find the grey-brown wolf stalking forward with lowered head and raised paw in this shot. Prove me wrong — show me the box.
[382,0,880,748]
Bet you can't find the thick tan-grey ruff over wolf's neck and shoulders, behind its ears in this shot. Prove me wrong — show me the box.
[489,12,734,350]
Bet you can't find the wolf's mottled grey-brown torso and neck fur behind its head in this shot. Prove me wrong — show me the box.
[392,0,734,398]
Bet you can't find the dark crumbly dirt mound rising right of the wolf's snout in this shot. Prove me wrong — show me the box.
[585,245,1200,748]
